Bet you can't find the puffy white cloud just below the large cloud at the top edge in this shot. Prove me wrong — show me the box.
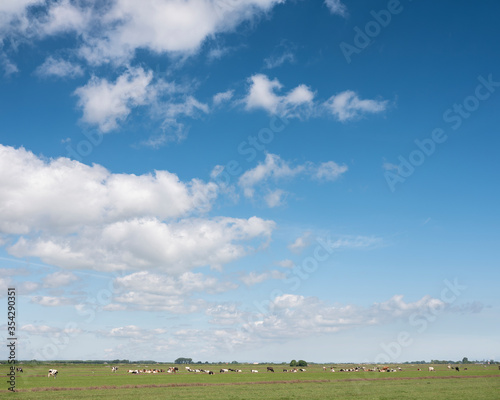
[75,67,153,132]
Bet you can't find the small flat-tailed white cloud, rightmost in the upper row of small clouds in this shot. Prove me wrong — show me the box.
[324,90,388,122]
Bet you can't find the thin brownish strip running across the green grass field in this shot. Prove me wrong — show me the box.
[5,375,500,392]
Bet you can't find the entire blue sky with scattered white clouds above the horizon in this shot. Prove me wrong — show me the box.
[0,0,500,362]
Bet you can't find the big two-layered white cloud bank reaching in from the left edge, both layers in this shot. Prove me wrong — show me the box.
[0,146,275,274]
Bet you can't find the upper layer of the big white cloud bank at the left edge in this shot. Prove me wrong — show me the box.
[0,145,217,234]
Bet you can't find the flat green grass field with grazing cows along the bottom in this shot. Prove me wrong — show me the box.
[0,364,500,400]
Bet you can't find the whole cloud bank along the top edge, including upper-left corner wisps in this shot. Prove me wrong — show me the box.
[0,0,284,65]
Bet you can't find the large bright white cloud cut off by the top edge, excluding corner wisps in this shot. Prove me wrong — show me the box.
[75,0,283,64]
